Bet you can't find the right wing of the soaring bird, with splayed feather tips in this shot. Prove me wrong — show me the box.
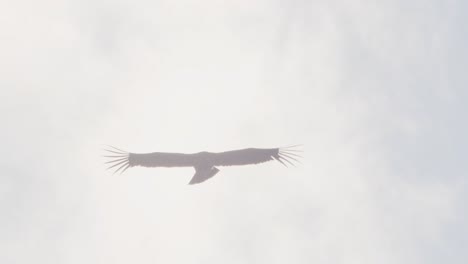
[213,146,300,167]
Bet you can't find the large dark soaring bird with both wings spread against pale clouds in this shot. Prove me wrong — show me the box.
[104,145,302,184]
